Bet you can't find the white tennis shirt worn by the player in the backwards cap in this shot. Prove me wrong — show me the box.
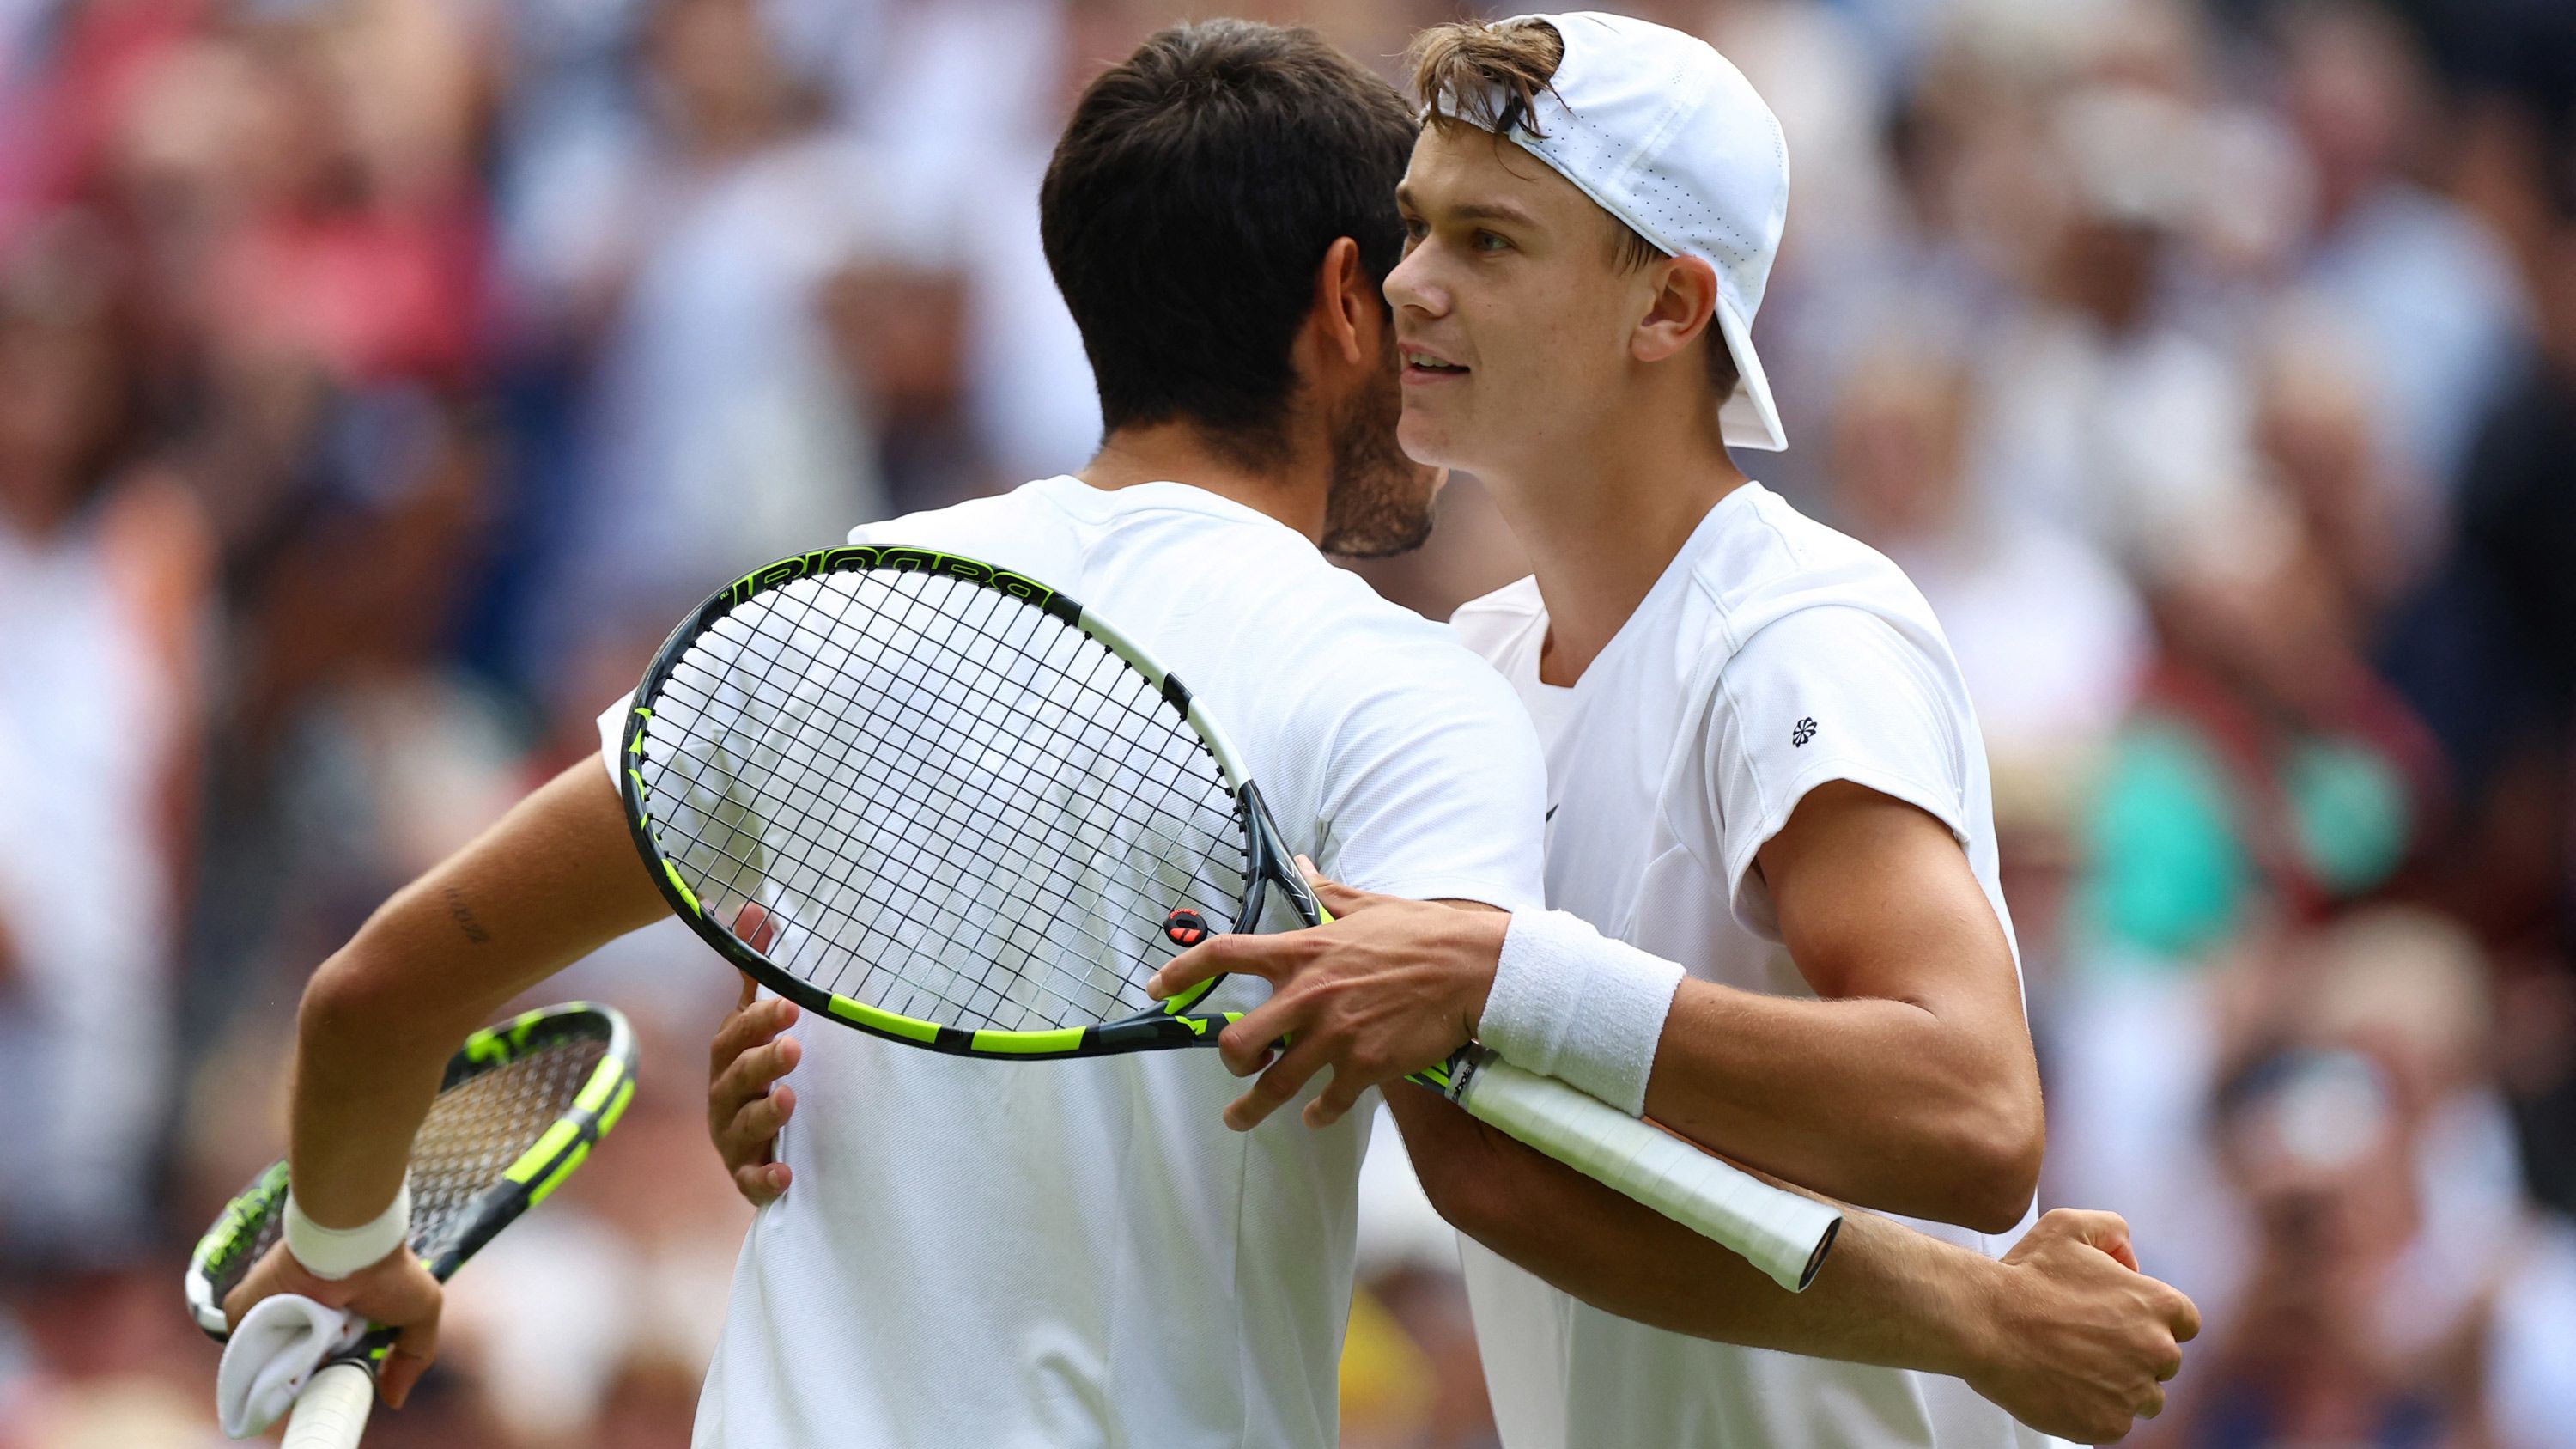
[1450,484,2056,1449]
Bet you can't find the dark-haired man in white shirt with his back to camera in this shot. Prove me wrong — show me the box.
[227,21,2161,1449]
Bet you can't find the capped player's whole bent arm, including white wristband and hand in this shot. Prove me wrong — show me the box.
[1149,782,2043,1233]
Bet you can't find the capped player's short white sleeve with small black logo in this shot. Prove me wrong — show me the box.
[1700,606,1976,941]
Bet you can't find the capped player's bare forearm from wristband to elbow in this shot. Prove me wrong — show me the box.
[1646,983,2040,1233]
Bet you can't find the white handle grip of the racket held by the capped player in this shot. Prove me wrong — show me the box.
[1458,1055,1842,1292]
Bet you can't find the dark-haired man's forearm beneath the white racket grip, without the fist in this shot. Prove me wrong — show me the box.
[1388,1086,1996,1374]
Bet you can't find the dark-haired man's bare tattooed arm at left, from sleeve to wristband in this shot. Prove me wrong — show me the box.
[291,761,662,1227]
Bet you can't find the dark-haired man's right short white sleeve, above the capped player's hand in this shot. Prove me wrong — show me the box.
[1316,621,1548,910]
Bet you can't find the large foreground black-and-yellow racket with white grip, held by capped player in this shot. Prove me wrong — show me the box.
[621,546,1842,1289]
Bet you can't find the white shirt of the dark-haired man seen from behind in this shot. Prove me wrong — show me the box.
[600,477,1546,1449]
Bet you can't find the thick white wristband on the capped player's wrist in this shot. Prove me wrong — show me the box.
[1476,910,1682,1117]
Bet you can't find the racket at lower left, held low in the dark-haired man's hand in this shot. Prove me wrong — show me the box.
[185,1001,636,1449]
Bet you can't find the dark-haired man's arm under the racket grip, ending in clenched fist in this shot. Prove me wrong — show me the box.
[1386,1083,2200,1444]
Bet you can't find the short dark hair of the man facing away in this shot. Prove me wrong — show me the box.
[1038,21,1414,464]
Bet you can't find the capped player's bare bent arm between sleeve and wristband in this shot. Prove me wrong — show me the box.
[1646,782,2043,1233]
